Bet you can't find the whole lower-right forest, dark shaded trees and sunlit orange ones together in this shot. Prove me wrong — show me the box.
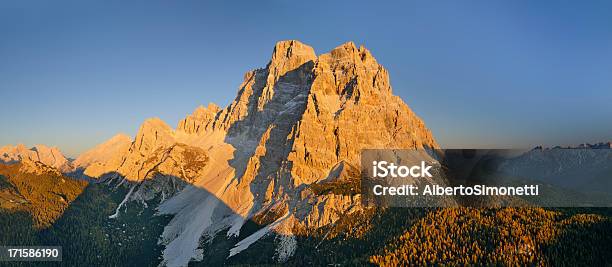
[202,208,612,266]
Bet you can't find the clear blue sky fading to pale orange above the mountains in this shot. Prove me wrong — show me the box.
[0,0,612,157]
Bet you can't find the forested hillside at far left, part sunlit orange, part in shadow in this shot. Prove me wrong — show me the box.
[0,165,168,266]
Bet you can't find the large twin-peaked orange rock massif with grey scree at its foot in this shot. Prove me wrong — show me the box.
[83,41,438,266]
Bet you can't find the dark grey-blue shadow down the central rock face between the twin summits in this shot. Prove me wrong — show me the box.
[225,61,314,214]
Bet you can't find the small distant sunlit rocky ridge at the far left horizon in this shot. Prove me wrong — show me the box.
[0,144,72,172]
